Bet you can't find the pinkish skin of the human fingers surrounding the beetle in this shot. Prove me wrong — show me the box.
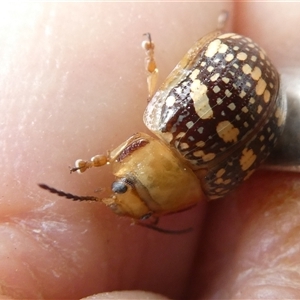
[0,3,300,299]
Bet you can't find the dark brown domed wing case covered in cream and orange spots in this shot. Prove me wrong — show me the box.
[144,32,286,199]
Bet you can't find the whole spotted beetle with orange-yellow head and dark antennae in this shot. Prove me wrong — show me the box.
[40,12,286,232]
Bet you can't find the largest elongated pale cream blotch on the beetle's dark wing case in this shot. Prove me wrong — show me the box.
[190,79,213,119]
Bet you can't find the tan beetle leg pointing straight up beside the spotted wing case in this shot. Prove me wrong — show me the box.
[142,33,158,101]
